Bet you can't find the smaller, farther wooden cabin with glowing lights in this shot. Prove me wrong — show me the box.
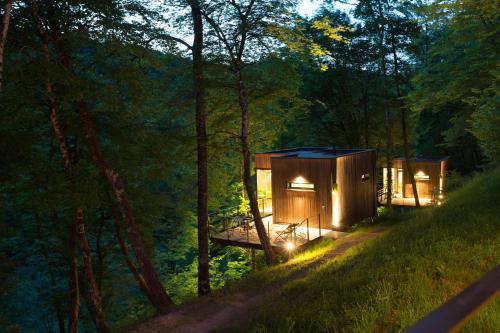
[382,157,448,206]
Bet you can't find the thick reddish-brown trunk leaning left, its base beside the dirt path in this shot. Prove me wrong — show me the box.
[41,0,174,313]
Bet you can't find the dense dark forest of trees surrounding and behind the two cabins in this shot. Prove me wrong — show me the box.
[0,0,500,333]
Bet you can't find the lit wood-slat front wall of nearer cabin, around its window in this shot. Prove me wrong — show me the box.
[270,157,335,229]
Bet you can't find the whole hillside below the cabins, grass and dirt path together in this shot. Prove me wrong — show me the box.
[132,169,500,332]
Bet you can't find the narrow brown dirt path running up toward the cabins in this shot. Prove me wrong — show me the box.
[129,227,387,333]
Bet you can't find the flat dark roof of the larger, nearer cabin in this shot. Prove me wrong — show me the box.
[257,147,375,158]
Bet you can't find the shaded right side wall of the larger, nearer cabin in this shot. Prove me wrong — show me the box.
[335,151,377,227]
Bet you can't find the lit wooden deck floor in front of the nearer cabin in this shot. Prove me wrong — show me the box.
[210,222,332,249]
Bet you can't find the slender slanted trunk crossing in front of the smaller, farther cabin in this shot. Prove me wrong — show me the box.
[391,28,420,207]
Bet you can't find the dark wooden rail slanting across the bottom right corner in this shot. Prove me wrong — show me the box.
[406,265,500,333]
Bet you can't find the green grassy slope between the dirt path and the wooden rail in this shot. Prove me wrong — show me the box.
[243,169,500,332]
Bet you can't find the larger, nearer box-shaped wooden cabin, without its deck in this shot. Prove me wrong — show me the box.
[255,148,377,230]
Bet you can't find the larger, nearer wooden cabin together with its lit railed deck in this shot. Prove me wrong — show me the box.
[210,148,377,251]
